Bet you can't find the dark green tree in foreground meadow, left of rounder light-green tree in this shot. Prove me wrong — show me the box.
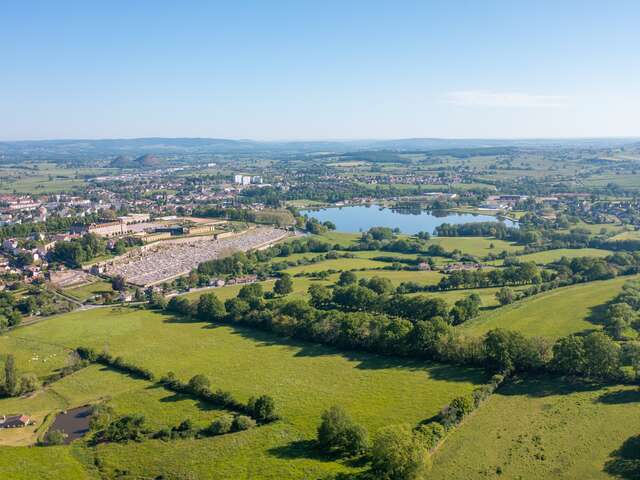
[318,406,369,455]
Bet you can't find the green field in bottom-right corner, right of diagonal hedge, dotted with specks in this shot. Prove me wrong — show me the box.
[428,378,640,480]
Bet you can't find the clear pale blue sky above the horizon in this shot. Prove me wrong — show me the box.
[0,0,640,140]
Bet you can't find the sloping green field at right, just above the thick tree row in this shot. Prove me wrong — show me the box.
[460,277,637,338]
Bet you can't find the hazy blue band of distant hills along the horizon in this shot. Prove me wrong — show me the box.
[0,138,639,168]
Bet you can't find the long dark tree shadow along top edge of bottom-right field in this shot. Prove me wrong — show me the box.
[500,375,603,398]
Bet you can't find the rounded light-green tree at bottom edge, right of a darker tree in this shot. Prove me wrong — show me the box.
[371,425,427,480]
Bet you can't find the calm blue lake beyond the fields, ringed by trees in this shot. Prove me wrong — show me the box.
[301,205,518,234]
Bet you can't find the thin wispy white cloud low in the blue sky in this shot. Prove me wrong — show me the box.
[446,90,569,108]
